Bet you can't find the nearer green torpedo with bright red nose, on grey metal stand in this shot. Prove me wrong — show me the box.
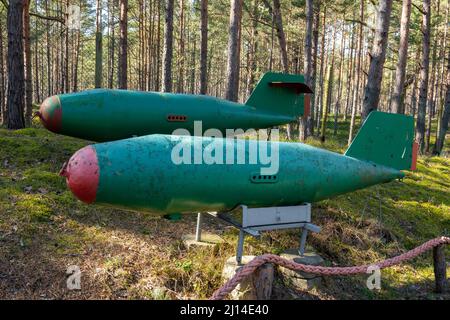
[61,112,416,214]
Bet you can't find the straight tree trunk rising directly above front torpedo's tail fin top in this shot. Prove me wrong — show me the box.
[392,0,411,113]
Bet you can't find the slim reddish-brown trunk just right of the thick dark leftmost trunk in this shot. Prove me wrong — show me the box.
[23,0,33,126]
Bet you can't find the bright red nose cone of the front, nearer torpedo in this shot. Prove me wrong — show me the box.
[60,146,100,203]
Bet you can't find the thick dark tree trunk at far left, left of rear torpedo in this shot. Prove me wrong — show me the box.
[6,0,25,129]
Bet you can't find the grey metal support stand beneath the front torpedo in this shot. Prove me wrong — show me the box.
[195,203,320,264]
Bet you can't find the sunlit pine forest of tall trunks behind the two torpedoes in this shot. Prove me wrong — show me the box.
[0,0,450,154]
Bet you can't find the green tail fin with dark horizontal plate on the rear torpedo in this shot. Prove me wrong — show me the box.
[245,72,313,119]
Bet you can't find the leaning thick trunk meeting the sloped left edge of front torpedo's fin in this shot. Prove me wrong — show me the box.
[362,0,392,119]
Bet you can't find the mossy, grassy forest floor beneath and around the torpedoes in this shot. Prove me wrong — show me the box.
[0,118,450,299]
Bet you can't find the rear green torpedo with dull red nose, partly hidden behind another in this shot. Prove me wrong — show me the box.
[37,72,312,142]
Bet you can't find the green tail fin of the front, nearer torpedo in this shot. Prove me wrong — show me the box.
[345,111,418,170]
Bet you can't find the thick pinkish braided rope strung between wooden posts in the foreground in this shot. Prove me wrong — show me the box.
[210,237,450,300]
